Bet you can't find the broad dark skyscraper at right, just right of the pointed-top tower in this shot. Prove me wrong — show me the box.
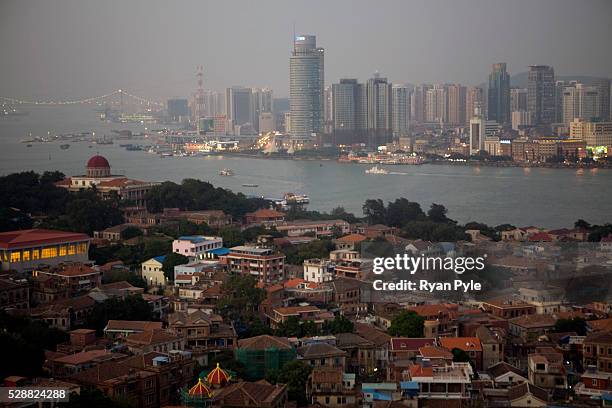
[527,65,555,125]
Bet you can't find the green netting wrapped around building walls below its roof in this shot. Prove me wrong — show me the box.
[236,347,297,380]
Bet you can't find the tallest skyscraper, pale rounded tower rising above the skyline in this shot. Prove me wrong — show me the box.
[289,35,324,142]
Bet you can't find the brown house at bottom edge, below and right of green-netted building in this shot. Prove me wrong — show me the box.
[306,367,357,408]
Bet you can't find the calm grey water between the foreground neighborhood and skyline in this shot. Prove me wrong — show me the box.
[0,106,612,228]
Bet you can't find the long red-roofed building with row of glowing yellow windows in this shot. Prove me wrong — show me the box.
[0,229,91,272]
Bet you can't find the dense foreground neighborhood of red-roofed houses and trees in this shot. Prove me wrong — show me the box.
[0,156,612,408]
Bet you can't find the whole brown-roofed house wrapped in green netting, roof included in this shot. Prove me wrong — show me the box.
[235,335,297,380]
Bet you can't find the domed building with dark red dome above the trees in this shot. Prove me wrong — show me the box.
[56,154,158,208]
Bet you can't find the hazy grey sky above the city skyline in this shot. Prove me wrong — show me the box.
[0,0,612,98]
